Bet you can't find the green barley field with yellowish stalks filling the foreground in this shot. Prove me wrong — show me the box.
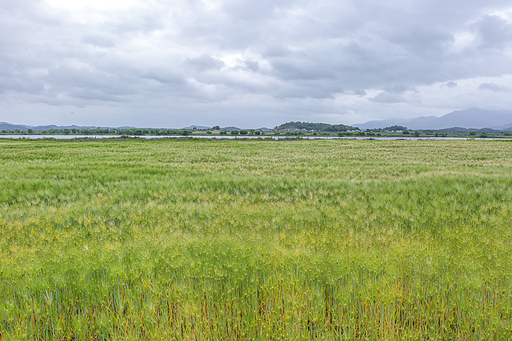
[0,140,512,340]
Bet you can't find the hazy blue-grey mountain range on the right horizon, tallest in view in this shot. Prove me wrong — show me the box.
[355,108,512,130]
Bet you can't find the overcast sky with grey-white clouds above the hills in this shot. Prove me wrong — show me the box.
[0,0,512,128]
